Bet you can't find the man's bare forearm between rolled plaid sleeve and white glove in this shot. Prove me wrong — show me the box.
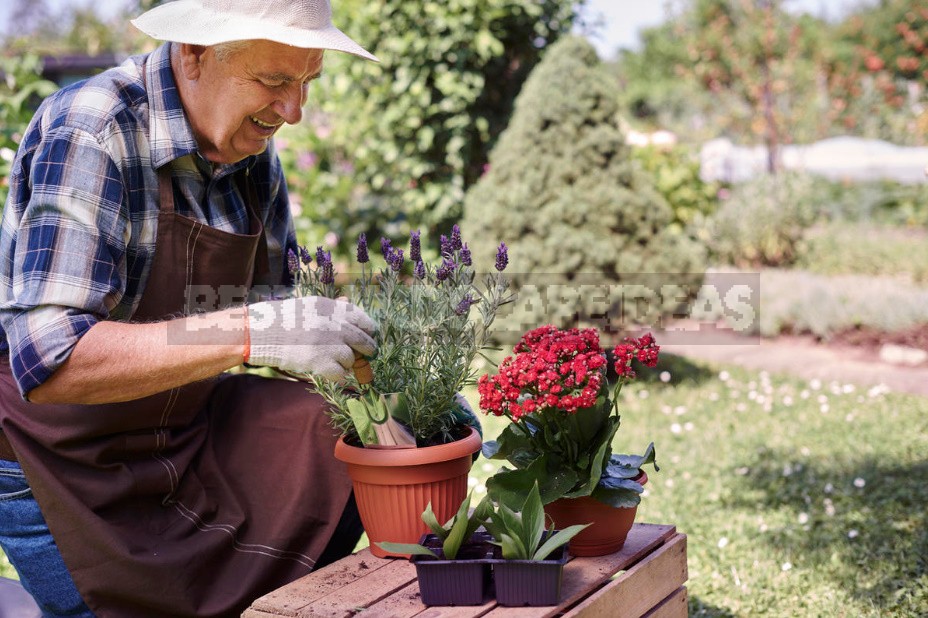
[27,307,245,404]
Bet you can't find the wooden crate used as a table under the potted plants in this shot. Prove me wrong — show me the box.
[242,524,687,618]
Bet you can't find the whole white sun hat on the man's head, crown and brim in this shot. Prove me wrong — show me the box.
[132,0,378,62]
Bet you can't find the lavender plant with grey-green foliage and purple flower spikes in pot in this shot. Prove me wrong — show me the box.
[297,232,513,446]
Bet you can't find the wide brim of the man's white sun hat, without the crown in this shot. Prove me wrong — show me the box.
[131,0,379,62]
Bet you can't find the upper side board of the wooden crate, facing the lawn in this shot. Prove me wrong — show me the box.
[566,534,687,618]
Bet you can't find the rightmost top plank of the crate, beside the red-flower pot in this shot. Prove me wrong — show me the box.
[478,524,682,618]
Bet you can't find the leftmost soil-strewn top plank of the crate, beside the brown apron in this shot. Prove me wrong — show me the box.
[248,549,405,618]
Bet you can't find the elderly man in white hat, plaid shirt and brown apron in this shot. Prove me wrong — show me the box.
[0,0,376,617]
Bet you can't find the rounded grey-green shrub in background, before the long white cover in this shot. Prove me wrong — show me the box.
[708,174,815,268]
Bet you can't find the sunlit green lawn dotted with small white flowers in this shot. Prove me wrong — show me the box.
[0,356,928,617]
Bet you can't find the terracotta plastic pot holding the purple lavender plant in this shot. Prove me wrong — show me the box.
[335,428,482,558]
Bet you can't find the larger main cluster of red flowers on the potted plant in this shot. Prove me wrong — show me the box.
[477,325,606,420]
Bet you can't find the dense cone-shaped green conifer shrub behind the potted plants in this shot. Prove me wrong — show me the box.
[462,37,703,333]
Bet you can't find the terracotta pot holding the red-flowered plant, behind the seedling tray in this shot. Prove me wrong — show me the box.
[545,471,648,556]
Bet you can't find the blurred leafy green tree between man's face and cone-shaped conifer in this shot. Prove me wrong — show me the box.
[303,0,576,251]
